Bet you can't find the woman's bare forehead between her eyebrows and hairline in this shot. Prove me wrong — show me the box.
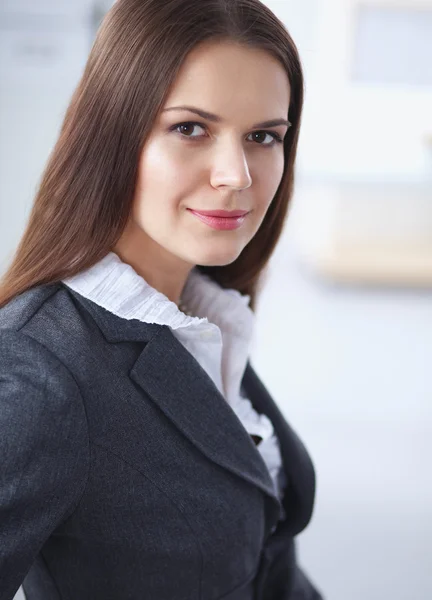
[165,41,291,120]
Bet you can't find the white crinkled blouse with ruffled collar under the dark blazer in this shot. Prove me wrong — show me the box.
[63,252,286,506]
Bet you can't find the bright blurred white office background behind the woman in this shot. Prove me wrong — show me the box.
[0,0,432,600]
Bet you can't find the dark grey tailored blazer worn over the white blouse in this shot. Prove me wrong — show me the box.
[0,282,321,600]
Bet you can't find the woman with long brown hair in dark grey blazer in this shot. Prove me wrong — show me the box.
[0,0,321,600]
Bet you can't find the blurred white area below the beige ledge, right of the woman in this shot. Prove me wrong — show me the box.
[252,203,432,600]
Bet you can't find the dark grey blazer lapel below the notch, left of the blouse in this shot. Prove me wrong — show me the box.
[130,326,280,506]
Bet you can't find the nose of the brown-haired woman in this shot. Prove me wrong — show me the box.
[211,144,252,190]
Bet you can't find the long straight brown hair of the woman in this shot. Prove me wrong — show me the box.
[0,0,304,308]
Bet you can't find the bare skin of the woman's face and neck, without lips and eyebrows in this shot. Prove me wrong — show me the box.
[113,41,291,304]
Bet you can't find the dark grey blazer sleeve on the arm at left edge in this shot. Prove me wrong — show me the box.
[0,330,89,600]
